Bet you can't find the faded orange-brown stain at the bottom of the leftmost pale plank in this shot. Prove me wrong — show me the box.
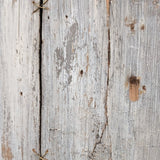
[2,142,13,160]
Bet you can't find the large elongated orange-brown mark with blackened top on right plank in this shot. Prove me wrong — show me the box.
[129,76,140,102]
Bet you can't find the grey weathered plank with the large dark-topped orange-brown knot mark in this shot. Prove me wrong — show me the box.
[108,0,160,160]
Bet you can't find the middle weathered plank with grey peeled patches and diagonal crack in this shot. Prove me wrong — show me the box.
[42,0,111,160]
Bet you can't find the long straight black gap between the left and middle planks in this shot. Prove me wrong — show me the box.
[39,0,43,155]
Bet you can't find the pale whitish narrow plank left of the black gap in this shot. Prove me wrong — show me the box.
[0,0,39,160]
